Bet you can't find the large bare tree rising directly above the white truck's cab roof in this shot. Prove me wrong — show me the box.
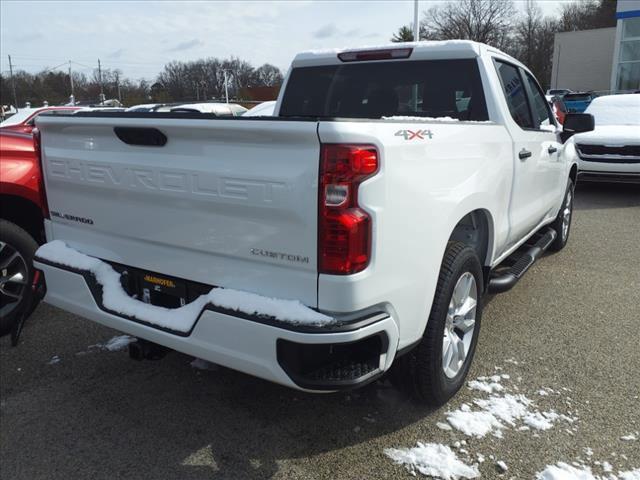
[421,0,516,48]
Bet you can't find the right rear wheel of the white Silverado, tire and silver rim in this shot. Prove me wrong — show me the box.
[393,242,483,406]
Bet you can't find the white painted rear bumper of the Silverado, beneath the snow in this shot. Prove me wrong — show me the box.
[34,242,398,391]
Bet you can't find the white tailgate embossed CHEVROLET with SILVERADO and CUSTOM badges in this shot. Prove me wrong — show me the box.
[38,116,319,306]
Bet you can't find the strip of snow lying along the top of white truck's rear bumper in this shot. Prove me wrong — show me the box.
[36,240,335,332]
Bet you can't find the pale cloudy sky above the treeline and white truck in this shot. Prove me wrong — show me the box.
[0,0,562,79]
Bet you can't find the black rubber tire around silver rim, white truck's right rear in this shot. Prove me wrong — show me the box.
[391,242,483,407]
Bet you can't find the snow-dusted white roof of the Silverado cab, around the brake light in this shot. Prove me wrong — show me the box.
[292,40,520,67]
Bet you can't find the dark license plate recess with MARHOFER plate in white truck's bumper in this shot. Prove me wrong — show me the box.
[111,264,212,308]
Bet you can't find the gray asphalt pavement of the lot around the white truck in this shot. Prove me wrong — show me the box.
[0,184,640,480]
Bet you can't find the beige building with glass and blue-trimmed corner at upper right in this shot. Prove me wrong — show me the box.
[551,0,640,92]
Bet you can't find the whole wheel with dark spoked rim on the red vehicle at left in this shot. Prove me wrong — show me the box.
[0,220,38,336]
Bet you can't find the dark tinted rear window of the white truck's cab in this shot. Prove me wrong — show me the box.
[280,59,489,121]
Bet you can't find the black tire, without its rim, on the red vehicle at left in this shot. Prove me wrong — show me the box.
[0,219,38,336]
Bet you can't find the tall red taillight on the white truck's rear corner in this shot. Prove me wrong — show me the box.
[318,144,378,275]
